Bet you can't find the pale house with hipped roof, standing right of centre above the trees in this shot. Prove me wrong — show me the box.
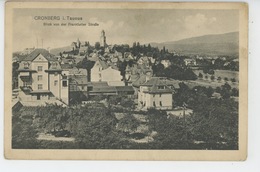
[138,77,174,110]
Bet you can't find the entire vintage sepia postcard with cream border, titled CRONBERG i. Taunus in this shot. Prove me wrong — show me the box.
[4,2,248,161]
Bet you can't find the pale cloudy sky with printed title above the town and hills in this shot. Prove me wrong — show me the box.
[13,9,239,51]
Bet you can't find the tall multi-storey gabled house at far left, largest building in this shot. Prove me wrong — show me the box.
[18,49,68,104]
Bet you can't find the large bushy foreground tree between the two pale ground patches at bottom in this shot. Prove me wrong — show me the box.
[70,105,124,149]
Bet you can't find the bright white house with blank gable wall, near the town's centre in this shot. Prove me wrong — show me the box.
[90,59,124,86]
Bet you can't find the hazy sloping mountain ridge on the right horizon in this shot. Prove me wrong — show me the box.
[150,32,239,56]
